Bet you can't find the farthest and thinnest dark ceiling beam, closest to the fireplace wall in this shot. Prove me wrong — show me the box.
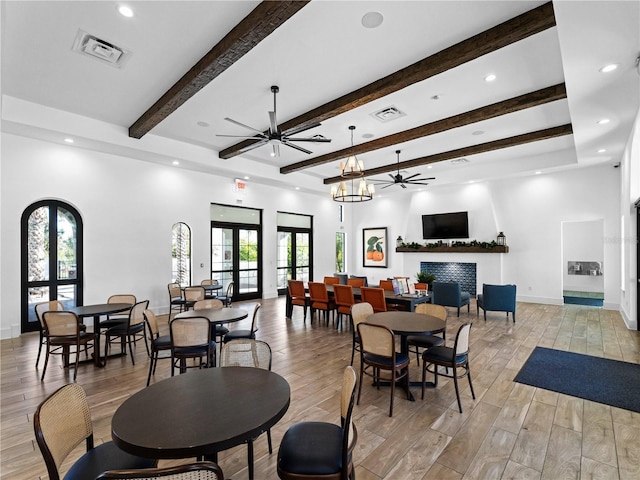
[324,124,573,185]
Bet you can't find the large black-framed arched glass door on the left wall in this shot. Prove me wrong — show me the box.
[20,200,83,333]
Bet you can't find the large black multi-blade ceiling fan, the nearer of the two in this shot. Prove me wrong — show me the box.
[216,85,331,157]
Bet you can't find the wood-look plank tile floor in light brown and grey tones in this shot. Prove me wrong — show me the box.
[0,298,640,480]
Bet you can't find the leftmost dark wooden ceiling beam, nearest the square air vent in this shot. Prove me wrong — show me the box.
[129,0,310,138]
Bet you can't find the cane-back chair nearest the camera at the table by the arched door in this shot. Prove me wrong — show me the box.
[40,310,99,382]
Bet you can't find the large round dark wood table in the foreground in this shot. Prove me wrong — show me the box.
[111,367,291,460]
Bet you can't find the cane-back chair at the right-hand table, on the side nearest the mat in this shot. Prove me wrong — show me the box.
[422,323,476,413]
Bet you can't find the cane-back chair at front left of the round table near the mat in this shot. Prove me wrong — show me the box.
[357,322,409,417]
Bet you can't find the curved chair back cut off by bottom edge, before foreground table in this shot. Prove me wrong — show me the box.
[96,462,224,480]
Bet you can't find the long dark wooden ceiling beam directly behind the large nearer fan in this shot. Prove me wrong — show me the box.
[219,2,556,158]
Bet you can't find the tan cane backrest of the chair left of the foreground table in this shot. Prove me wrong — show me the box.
[33,383,93,480]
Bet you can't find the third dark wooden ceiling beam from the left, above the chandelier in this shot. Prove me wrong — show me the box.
[280,83,567,174]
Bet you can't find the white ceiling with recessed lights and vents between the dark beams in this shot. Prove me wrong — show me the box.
[2,0,640,194]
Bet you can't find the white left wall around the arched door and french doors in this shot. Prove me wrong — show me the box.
[0,134,338,338]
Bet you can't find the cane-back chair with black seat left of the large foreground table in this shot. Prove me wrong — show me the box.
[33,383,157,480]
